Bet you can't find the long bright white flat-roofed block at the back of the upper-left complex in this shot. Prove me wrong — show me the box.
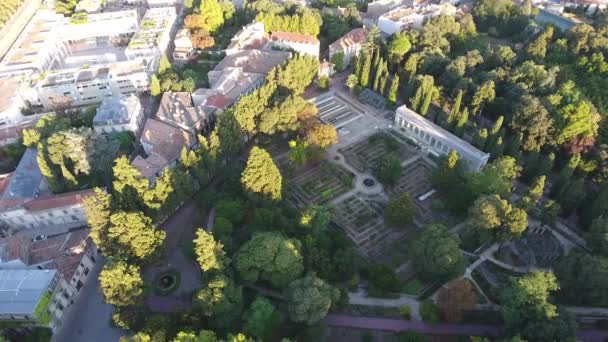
[61,9,139,42]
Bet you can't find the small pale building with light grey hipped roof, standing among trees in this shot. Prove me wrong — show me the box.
[93,94,145,136]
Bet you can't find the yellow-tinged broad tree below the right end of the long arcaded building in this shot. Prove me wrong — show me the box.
[467,195,528,240]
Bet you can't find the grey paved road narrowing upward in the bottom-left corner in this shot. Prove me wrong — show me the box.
[51,262,125,342]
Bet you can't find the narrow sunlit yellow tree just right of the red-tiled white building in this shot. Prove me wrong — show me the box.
[82,188,113,255]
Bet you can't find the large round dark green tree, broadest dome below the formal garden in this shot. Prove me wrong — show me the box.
[234,232,304,287]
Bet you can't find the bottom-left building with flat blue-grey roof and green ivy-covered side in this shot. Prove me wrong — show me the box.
[0,269,59,325]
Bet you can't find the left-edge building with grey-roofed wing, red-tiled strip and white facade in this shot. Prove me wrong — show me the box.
[0,148,91,235]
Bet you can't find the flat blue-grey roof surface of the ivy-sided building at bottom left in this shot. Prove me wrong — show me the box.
[0,270,57,315]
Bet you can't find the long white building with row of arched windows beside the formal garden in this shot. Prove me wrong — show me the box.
[395,105,490,171]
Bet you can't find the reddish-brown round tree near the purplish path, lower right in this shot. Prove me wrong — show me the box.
[437,279,477,322]
